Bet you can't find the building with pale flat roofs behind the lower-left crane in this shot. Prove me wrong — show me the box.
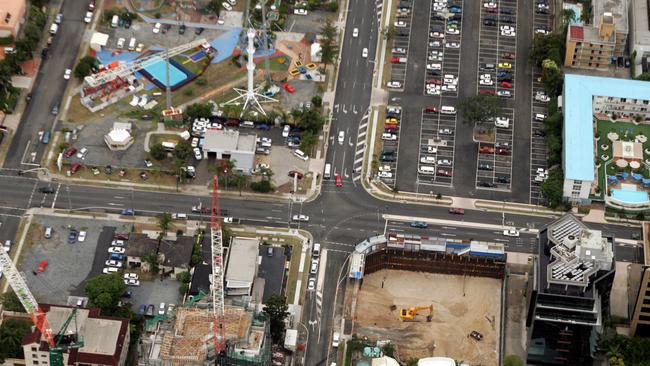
[23,305,129,364]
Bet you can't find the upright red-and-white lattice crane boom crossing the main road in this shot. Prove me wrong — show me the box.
[210,175,226,357]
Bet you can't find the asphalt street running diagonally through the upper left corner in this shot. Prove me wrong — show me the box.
[4,1,86,168]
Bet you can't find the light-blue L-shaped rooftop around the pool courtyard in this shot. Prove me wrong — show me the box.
[562,74,650,181]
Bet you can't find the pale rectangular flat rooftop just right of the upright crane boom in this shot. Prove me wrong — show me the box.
[226,237,259,288]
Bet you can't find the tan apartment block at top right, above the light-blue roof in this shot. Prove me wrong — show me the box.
[564,0,629,69]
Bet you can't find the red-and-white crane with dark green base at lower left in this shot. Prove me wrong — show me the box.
[0,250,84,366]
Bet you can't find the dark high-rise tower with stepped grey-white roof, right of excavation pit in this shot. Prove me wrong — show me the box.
[526,214,615,366]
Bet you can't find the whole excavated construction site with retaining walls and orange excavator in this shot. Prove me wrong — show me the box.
[346,235,505,366]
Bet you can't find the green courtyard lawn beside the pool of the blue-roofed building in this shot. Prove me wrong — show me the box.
[596,120,650,196]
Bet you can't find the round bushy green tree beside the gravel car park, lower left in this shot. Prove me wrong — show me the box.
[86,273,127,315]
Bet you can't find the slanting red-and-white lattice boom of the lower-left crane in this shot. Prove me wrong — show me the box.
[0,250,55,347]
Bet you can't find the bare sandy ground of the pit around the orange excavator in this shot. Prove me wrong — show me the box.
[354,270,501,366]
